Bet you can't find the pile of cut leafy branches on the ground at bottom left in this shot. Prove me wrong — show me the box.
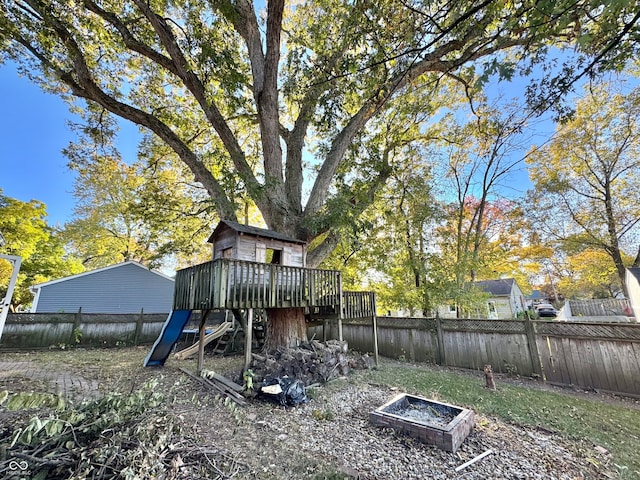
[0,384,249,480]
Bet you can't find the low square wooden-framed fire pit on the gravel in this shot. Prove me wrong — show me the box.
[369,393,474,452]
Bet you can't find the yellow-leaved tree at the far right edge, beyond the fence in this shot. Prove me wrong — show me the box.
[528,83,640,295]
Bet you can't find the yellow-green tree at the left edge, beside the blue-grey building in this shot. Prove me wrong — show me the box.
[0,190,84,310]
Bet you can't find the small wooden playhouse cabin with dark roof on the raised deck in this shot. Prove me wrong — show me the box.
[208,220,307,268]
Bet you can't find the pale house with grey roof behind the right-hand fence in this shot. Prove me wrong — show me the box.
[438,278,526,320]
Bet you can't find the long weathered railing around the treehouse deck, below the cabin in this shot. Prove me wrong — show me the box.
[173,259,341,310]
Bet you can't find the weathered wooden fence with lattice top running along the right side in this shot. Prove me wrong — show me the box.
[316,317,640,396]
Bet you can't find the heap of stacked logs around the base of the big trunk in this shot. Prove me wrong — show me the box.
[246,340,373,386]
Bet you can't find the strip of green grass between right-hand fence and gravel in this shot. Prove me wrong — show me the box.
[364,363,640,478]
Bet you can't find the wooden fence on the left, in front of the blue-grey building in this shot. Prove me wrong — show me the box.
[0,312,167,349]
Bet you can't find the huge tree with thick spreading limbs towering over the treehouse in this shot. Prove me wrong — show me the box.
[0,0,640,344]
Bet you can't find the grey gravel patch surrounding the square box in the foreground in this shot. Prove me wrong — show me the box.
[179,380,613,480]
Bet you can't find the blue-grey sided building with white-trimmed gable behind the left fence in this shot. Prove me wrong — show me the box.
[31,261,174,313]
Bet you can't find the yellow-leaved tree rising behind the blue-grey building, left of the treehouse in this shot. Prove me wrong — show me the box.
[63,117,214,269]
